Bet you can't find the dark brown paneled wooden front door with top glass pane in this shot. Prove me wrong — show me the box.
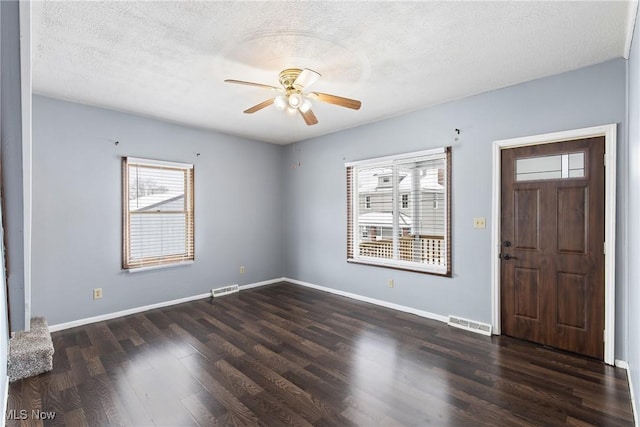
[500,137,605,359]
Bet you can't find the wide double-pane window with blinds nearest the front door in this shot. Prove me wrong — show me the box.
[346,148,451,276]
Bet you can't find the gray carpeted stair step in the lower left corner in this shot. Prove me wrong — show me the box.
[8,317,53,381]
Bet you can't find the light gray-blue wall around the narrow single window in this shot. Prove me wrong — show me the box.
[30,94,283,325]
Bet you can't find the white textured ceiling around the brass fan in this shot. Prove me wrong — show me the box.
[32,1,631,144]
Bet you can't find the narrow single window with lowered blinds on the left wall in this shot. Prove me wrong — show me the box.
[122,157,194,269]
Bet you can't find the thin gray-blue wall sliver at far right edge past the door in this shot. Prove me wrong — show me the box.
[627,3,640,418]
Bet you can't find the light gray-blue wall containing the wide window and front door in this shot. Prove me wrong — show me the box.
[283,60,626,358]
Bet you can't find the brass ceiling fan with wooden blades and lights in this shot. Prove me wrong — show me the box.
[225,68,362,126]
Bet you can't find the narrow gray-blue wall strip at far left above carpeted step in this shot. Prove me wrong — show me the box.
[0,1,24,331]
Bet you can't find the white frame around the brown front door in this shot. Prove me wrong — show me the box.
[491,123,617,365]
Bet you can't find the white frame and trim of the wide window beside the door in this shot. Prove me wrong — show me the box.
[344,147,453,277]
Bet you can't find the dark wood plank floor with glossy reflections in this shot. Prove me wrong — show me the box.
[7,284,633,427]
